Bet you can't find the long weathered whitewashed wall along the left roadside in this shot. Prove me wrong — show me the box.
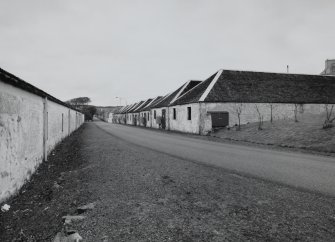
[0,80,84,202]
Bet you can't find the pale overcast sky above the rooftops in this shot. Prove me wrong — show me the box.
[0,0,335,106]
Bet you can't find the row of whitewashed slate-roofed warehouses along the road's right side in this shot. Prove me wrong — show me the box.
[109,70,335,135]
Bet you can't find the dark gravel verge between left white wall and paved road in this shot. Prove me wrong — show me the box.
[0,123,335,241]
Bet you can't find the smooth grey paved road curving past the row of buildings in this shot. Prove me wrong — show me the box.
[95,122,335,196]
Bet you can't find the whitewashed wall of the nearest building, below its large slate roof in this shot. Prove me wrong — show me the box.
[169,103,325,135]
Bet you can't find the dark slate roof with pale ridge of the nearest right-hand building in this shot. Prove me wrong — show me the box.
[173,70,335,105]
